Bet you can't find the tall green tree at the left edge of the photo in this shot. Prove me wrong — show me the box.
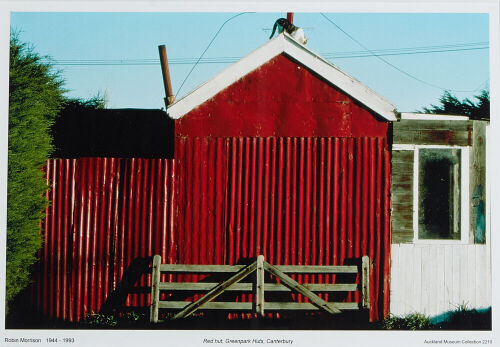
[6,34,65,308]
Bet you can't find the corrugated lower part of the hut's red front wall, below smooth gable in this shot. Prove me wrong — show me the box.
[176,137,390,320]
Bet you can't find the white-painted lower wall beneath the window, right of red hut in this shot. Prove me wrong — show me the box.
[390,242,491,317]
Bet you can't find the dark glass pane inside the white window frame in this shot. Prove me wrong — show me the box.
[418,148,460,240]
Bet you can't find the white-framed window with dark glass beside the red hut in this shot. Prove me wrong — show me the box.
[413,146,469,243]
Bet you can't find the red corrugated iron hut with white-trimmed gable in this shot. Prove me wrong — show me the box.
[167,33,396,320]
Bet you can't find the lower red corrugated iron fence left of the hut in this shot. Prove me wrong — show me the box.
[33,158,175,321]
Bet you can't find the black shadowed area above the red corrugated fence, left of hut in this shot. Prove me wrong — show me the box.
[52,108,174,158]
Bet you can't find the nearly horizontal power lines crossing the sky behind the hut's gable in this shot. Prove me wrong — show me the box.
[43,42,489,66]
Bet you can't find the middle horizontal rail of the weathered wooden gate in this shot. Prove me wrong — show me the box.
[159,282,359,292]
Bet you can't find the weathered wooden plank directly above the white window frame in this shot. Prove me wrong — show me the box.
[393,130,470,146]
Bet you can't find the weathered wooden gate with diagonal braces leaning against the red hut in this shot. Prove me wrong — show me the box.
[150,255,370,323]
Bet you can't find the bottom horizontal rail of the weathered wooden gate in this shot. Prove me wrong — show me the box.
[159,301,359,311]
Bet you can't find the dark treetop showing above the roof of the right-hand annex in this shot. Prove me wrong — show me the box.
[423,90,490,119]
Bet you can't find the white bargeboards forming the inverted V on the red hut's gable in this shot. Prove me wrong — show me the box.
[167,33,397,121]
